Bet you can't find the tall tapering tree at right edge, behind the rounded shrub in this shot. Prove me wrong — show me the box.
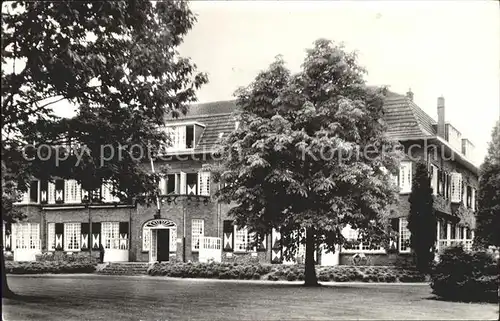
[474,122,500,248]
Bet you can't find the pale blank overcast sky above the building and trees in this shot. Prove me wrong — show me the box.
[180,1,500,165]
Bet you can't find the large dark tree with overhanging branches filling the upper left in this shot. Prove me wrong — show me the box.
[2,1,207,295]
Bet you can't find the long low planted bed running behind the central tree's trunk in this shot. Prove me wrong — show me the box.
[148,263,426,282]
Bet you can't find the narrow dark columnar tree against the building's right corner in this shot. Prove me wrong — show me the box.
[408,162,437,272]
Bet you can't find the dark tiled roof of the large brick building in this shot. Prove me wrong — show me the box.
[167,92,444,152]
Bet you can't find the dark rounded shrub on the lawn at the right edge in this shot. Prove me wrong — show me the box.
[431,247,498,302]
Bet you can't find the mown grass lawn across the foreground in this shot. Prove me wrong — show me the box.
[2,275,498,321]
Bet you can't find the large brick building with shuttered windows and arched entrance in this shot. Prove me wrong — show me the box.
[3,92,478,265]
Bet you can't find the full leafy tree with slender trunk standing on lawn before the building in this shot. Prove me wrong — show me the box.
[217,39,398,286]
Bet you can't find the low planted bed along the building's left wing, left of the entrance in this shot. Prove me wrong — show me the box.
[5,261,95,274]
